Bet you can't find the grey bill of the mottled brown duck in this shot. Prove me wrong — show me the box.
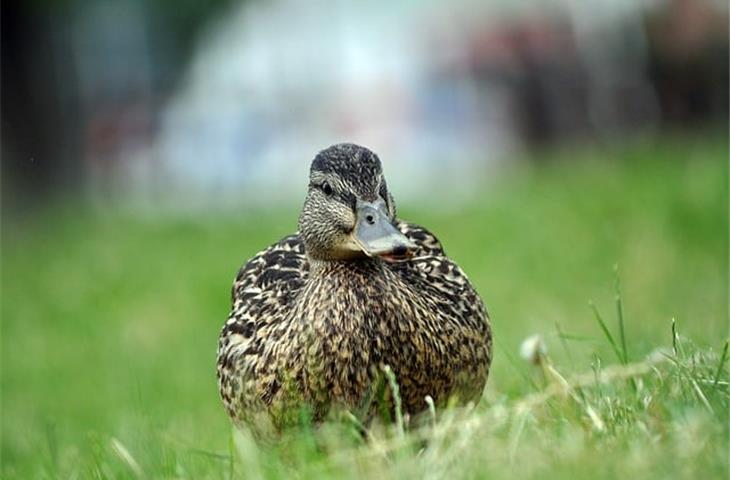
[353,200,416,262]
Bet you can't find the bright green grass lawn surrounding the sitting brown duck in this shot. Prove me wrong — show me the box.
[2,136,730,478]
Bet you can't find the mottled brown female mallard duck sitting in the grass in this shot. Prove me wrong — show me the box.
[217,144,492,427]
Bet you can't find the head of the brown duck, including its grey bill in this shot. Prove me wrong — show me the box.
[299,143,416,261]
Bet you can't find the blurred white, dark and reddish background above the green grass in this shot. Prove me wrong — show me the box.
[3,0,728,210]
